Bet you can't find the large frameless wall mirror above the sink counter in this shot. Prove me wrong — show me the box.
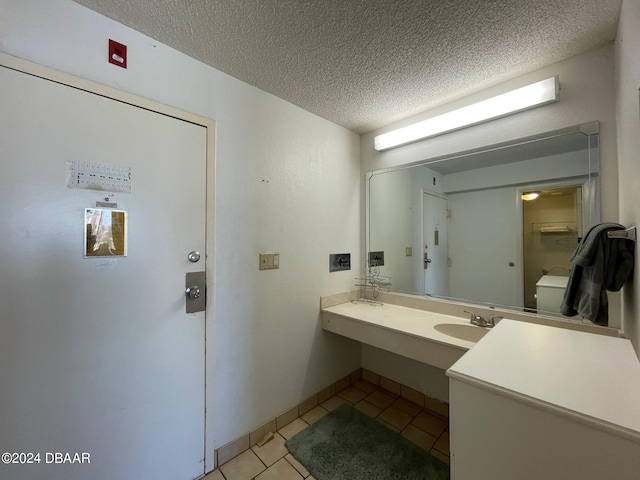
[366,122,600,316]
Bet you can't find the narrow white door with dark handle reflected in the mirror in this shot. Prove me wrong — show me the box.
[422,192,449,297]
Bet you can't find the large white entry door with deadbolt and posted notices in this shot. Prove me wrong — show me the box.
[0,64,206,480]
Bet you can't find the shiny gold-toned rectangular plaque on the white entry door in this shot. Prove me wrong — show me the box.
[84,208,127,258]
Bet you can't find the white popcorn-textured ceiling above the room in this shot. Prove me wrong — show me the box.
[75,0,622,133]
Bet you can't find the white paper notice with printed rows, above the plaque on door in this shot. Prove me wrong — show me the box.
[68,160,131,193]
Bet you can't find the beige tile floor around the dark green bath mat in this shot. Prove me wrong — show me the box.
[203,380,449,480]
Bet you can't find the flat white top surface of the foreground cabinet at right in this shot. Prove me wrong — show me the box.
[447,320,640,441]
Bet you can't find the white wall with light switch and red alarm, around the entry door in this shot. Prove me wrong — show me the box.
[0,0,361,469]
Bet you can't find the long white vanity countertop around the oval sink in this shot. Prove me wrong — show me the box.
[322,302,480,351]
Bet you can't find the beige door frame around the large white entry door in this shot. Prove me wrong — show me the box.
[0,52,216,473]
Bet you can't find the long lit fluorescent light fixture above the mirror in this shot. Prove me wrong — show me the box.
[373,75,559,151]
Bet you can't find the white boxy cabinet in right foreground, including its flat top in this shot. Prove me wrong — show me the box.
[447,320,640,480]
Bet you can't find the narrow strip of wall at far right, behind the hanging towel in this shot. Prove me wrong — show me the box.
[615,0,640,356]
